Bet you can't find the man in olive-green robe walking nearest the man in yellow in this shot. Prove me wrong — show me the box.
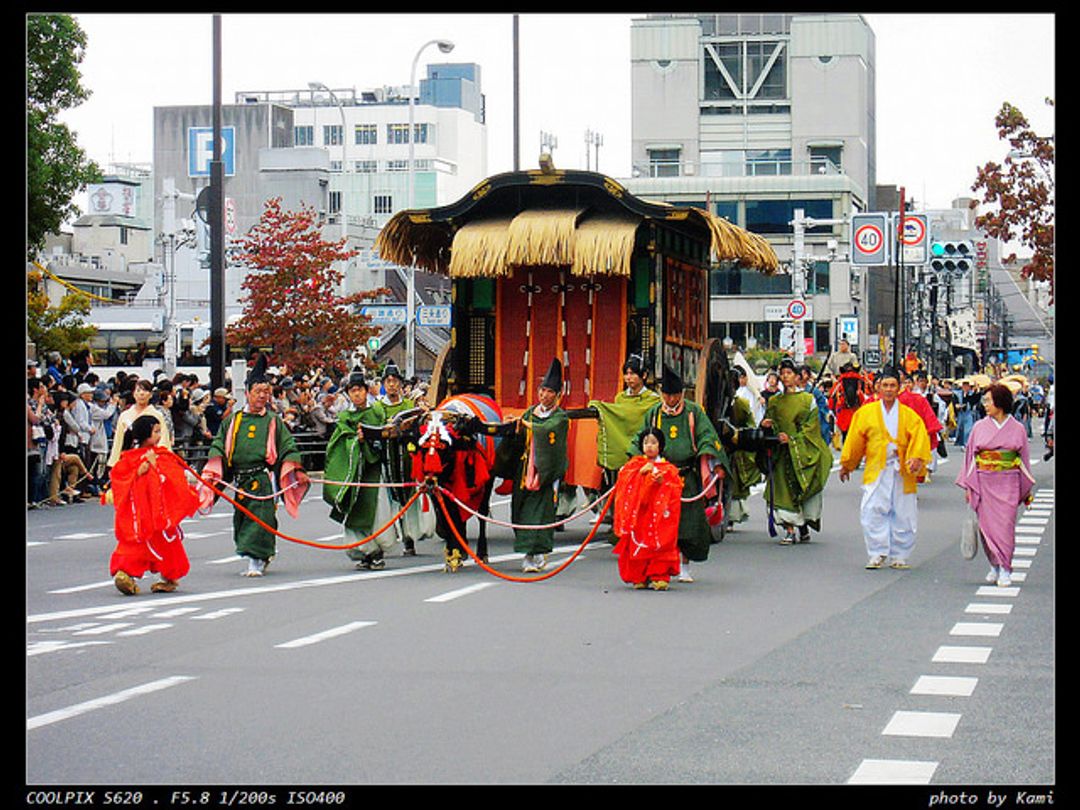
[761,360,833,545]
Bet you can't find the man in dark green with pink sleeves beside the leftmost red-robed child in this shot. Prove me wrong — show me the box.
[202,354,310,577]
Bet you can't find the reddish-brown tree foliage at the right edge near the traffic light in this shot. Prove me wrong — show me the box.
[971,98,1054,299]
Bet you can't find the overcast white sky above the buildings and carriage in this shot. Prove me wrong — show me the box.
[64,14,1055,208]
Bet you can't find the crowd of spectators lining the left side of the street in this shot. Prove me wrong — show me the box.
[26,352,427,509]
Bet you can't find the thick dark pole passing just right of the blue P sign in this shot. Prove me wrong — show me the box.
[210,14,228,389]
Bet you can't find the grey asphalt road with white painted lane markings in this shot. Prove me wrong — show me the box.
[26,440,1056,794]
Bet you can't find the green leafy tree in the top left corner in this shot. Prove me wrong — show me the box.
[26,14,102,258]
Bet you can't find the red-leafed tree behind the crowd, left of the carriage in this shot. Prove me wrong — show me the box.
[226,198,386,370]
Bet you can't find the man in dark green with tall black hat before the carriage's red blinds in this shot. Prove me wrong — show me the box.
[510,360,570,573]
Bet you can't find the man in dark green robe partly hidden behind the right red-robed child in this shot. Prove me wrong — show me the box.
[636,366,730,582]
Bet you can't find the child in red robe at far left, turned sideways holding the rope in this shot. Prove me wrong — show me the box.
[109,416,199,595]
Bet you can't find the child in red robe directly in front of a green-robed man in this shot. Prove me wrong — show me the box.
[611,428,683,591]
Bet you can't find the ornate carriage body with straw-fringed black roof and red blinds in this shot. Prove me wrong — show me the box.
[376,171,779,483]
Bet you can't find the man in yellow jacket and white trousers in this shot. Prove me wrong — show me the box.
[839,368,930,569]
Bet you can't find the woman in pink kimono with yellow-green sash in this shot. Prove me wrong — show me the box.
[956,382,1035,585]
